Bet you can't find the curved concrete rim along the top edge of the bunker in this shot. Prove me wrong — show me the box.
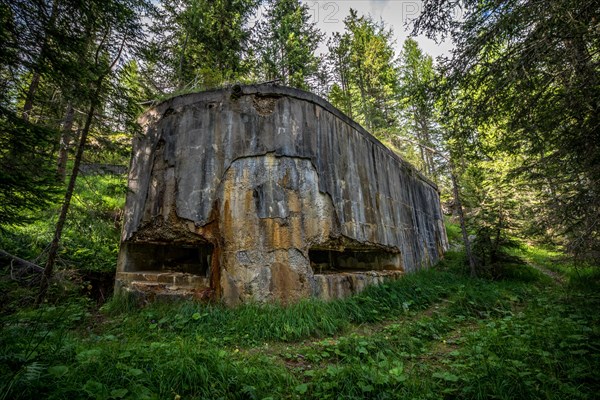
[138,84,439,193]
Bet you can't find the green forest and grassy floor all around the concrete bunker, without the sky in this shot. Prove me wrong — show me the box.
[0,0,600,400]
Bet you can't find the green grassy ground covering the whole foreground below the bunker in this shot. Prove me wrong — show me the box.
[0,245,600,399]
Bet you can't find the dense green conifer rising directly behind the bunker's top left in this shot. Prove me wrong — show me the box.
[146,0,260,90]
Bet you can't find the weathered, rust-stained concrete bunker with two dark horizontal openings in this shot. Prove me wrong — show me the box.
[117,85,447,304]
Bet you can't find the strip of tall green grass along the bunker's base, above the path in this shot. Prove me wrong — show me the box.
[104,270,468,346]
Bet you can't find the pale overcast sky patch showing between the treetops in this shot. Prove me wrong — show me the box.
[251,0,452,59]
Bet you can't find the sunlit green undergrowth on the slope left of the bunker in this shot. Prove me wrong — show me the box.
[0,174,127,313]
